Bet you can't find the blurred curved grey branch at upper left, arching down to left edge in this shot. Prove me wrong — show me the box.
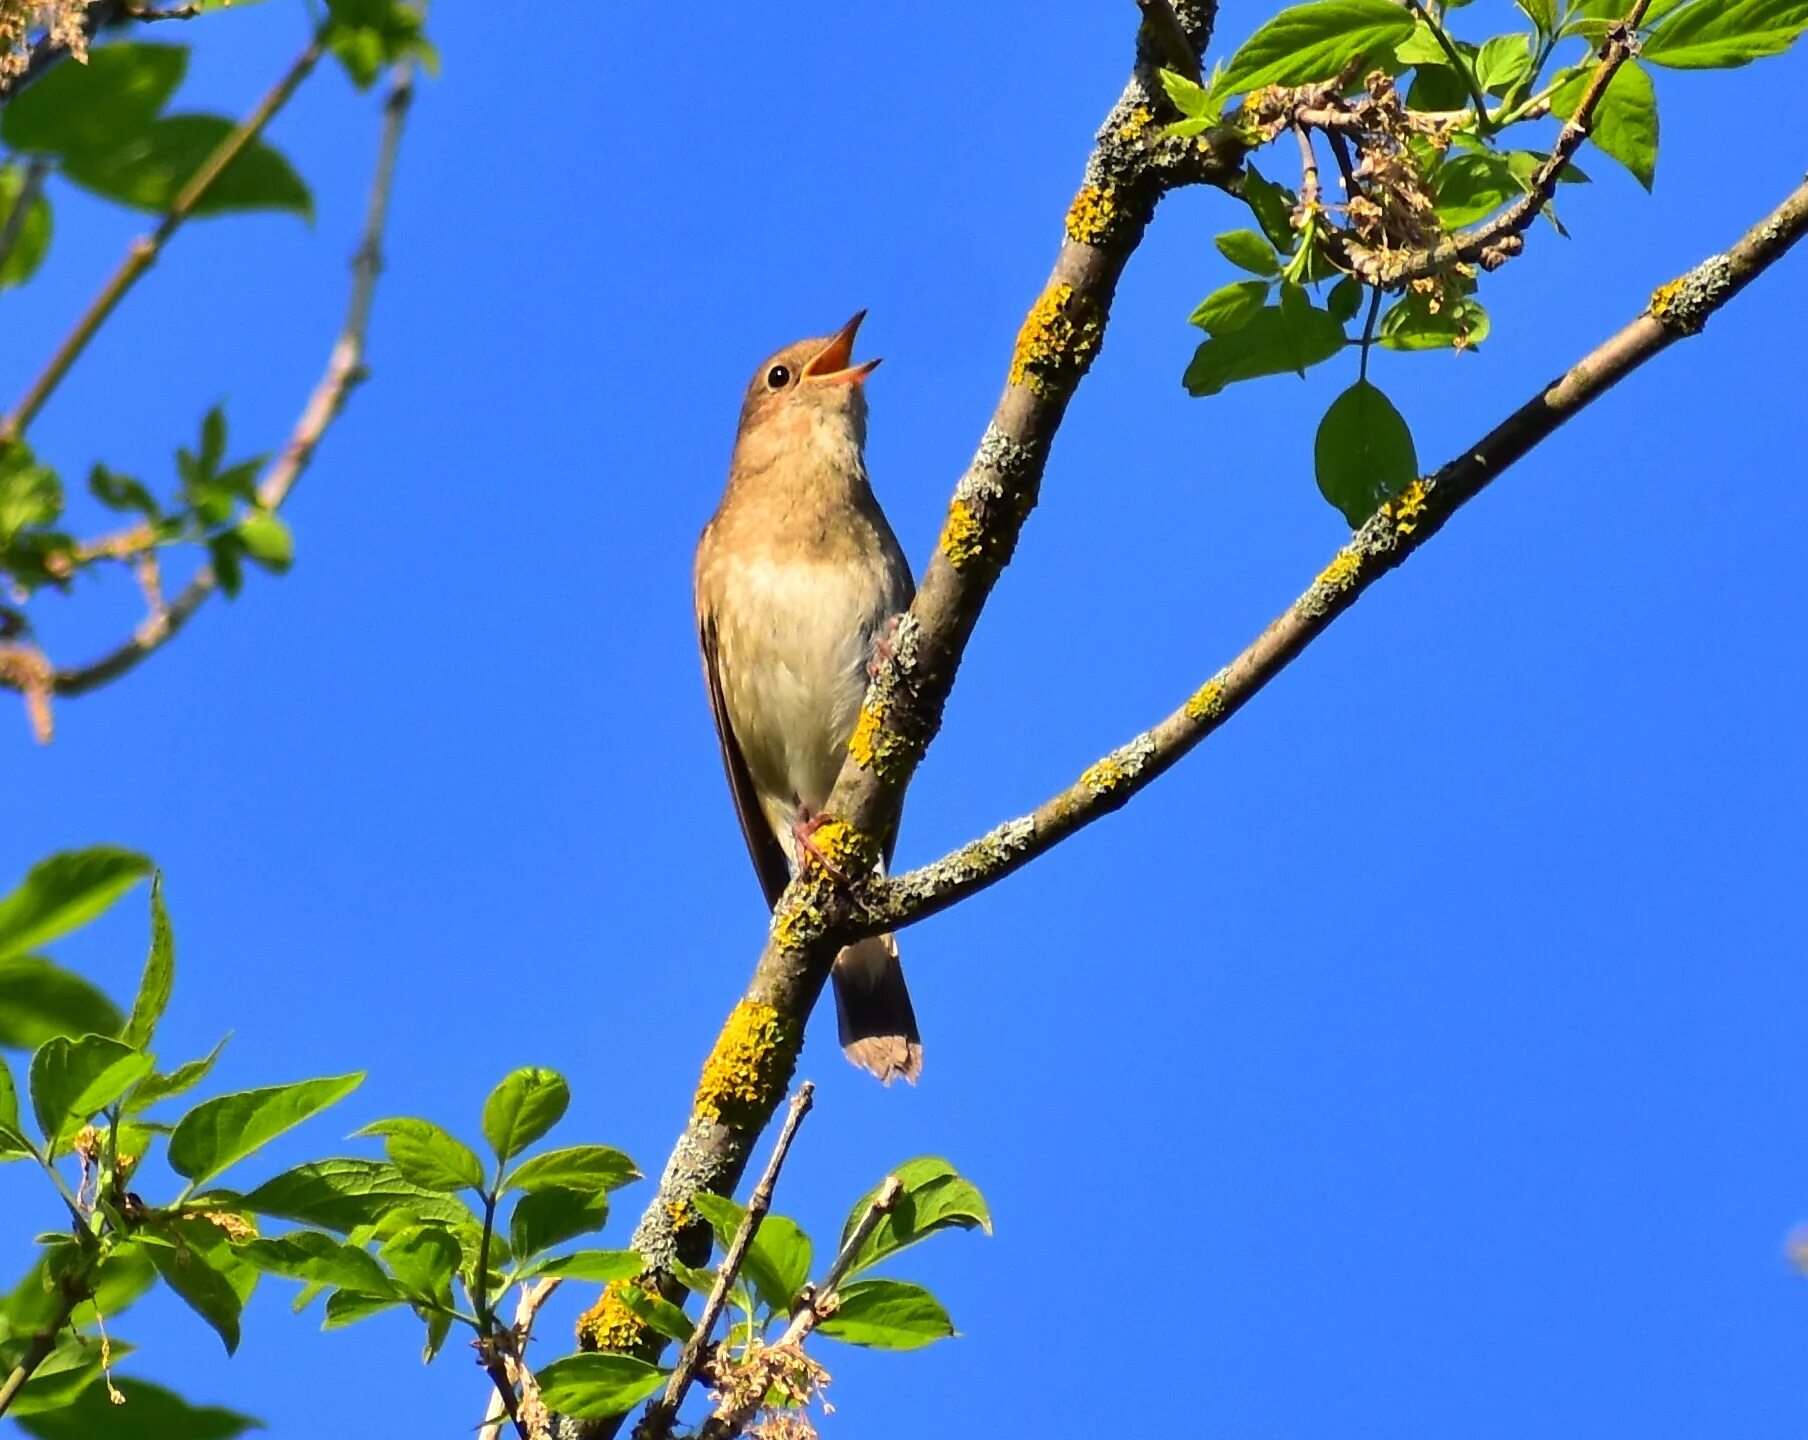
[0,62,414,706]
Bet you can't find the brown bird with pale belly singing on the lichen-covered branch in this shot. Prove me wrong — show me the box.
[696,311,922,1084]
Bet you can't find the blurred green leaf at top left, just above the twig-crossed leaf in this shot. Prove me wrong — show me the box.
[0,43,188,156]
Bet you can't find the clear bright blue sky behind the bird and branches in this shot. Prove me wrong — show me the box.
[0,0,1808,1440]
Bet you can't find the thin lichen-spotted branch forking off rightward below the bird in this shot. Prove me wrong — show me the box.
[861,171,1808,933]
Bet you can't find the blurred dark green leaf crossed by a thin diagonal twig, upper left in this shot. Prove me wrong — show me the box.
[63,116,315,221]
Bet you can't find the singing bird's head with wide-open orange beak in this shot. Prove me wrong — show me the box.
[736,309,879,465]
